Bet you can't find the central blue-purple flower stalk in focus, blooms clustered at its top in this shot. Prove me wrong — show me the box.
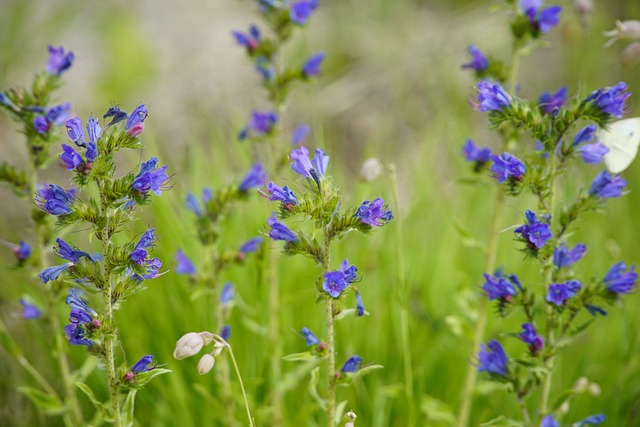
[265,146,393,426]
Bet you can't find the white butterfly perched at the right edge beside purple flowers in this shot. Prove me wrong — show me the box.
[598,117,640,174]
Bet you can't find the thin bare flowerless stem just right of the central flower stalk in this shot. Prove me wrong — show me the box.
[389,164,416,426]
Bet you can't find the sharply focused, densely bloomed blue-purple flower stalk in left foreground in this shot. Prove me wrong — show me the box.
[36,104,170,426]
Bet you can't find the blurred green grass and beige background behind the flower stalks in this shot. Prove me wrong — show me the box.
[0,0,640,427]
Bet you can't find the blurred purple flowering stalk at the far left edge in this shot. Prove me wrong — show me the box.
[0,46,84,425]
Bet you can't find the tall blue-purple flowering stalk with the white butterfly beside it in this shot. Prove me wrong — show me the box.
[466,13,638,426]
